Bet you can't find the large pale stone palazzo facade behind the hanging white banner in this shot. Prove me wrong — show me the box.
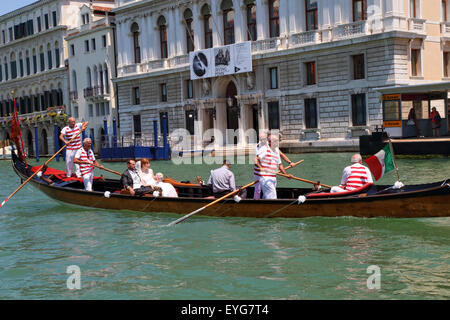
[114,0,450,150]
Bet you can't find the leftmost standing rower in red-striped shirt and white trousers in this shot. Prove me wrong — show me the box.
[59,117,88,178]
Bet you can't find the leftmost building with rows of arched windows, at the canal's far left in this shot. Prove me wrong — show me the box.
[0,0,114,155]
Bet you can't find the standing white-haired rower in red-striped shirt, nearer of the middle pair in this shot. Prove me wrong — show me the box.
[255,134,293,199]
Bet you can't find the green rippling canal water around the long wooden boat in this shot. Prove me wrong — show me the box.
[0,153,450,299]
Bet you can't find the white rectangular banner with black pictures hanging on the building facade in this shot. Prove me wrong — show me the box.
[189,41,253,80]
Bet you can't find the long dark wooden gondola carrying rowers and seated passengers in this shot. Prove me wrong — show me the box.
[12,153,450,218]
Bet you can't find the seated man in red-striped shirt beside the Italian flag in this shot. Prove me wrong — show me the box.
[330,154,373,193]
